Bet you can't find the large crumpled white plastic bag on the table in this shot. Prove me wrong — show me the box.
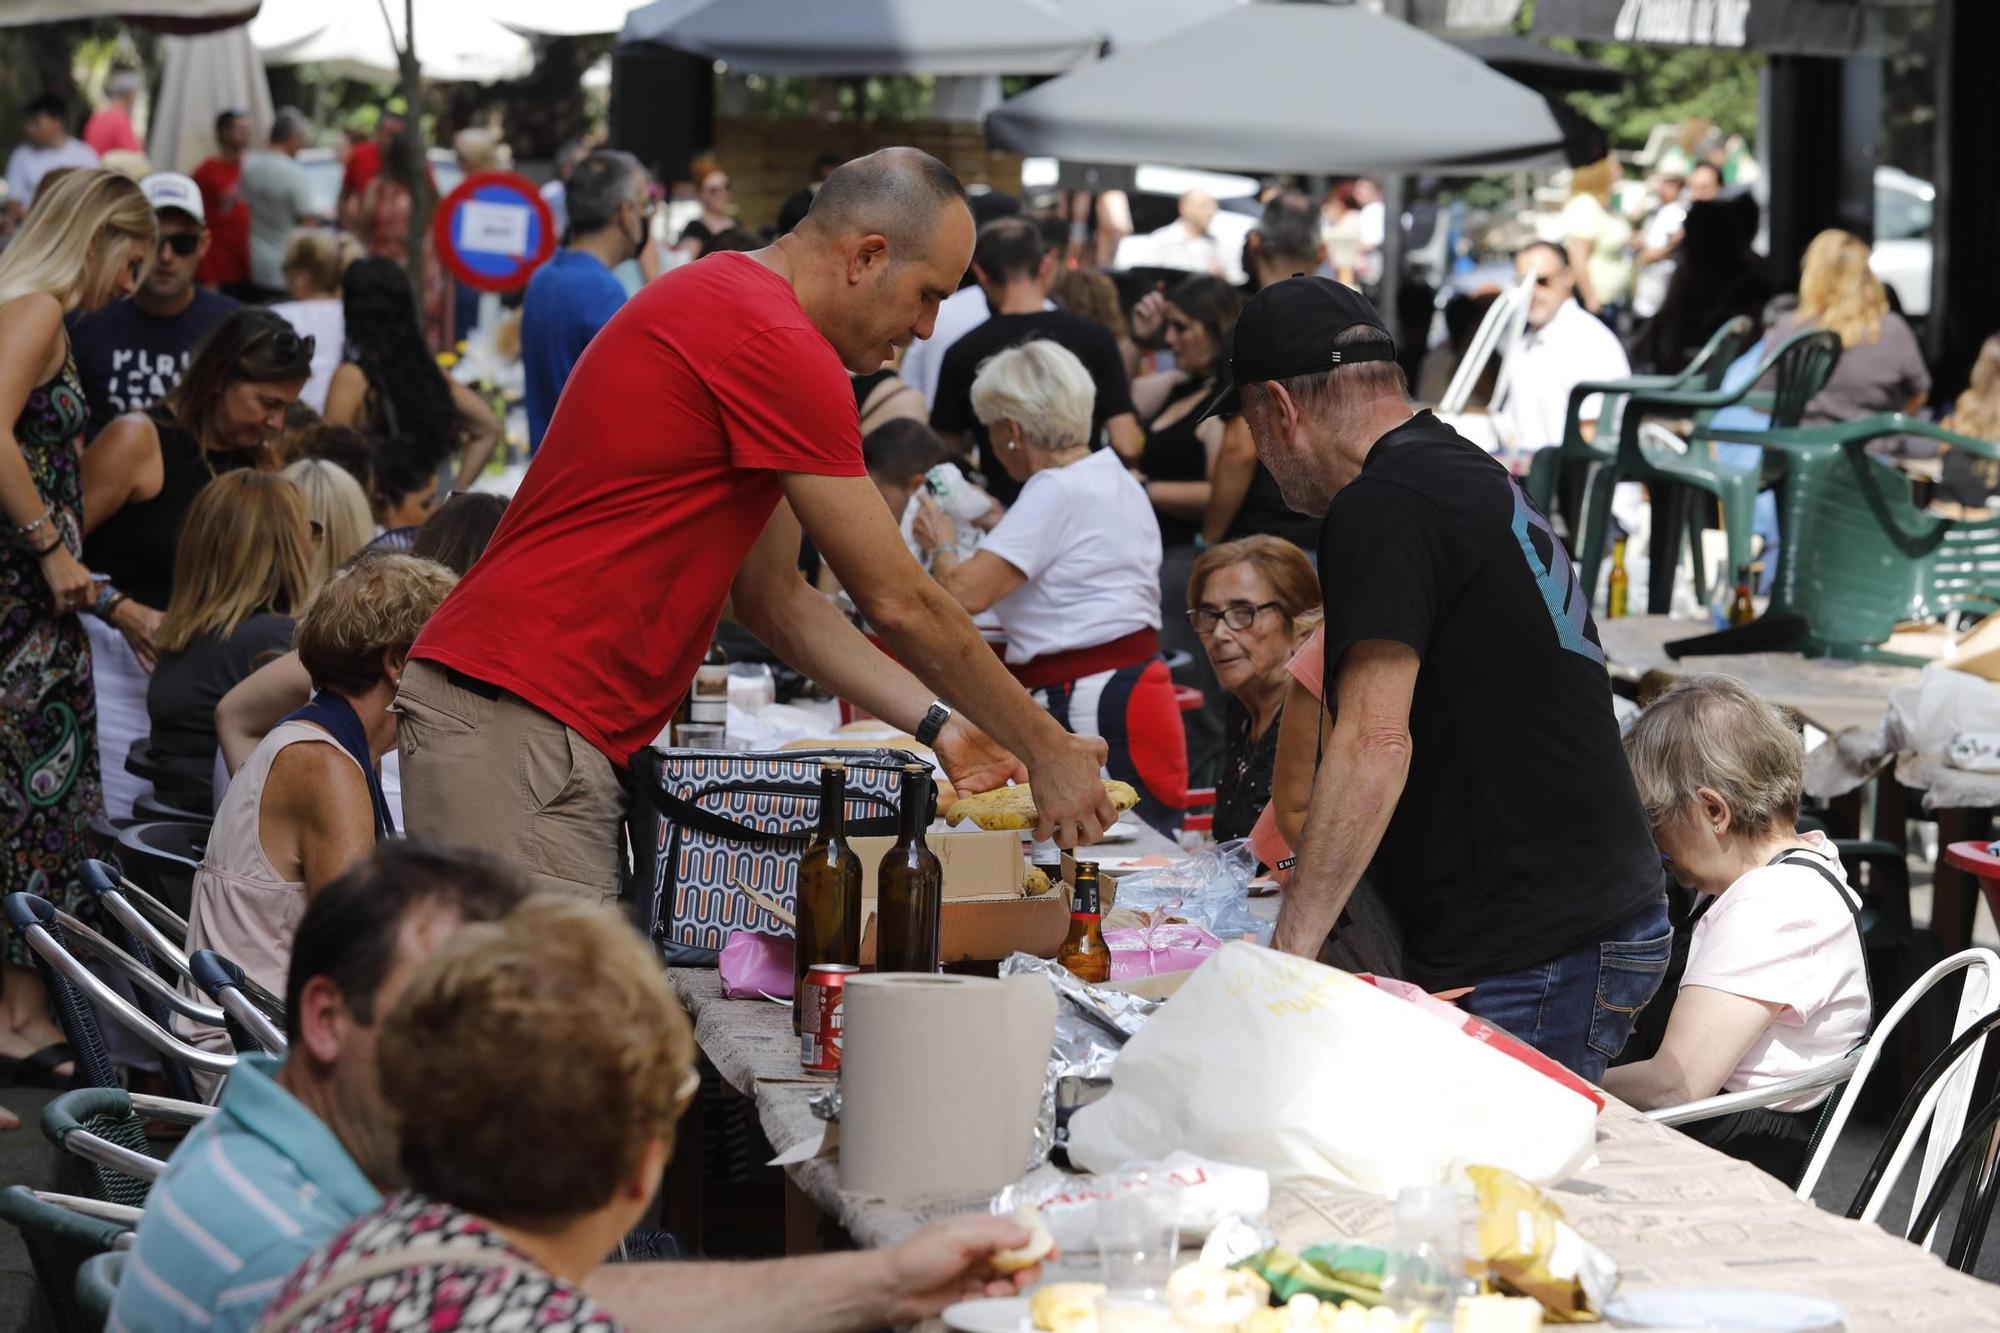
[1070,941,1602,1195]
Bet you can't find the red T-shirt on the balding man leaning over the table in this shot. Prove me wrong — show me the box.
[412,252,864,767]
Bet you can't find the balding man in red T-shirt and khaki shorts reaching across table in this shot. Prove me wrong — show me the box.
[396,148,1114,897]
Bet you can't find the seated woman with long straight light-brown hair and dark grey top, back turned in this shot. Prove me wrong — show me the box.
[146,472,316,811]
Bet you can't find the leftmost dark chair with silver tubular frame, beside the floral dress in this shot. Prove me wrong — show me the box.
[4,893,236,1101]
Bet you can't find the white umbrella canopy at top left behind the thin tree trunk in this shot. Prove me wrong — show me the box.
[250,0,534,84]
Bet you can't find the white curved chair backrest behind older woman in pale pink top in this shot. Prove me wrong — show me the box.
[1798,949,2000,1221]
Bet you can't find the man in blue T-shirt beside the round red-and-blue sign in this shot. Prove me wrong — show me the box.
[520,148,652,450]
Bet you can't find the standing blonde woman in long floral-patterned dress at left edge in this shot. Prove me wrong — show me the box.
[0,170,154,1096]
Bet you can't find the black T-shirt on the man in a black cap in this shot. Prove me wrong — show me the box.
[1320,412,1660,989]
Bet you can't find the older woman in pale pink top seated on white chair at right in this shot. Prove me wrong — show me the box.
[1604,675,1872,1183]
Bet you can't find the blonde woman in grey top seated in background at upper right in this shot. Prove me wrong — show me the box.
[1774,230,1930,436]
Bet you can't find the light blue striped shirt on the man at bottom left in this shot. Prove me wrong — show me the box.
[106,1055,382,1333]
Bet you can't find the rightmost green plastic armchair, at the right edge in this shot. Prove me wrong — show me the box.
[1668,412,2000,667]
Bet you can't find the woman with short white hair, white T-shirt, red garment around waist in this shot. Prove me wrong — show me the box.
[914,340,1188,829]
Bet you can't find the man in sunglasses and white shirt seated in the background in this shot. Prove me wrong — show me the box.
[1494,240,1632,462]
